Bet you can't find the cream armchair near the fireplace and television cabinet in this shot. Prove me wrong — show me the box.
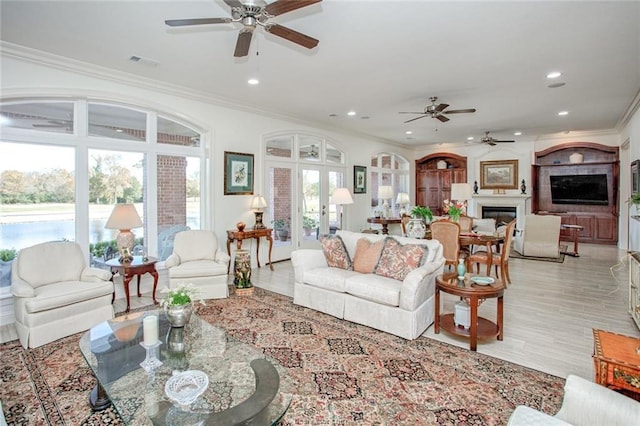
[513,214,562,258]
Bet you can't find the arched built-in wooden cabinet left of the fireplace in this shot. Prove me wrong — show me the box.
[416,153,467,215]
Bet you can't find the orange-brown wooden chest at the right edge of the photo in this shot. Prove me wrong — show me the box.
[593,328,640,401]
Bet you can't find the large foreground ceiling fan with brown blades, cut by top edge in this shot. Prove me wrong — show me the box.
[164,0,322,58]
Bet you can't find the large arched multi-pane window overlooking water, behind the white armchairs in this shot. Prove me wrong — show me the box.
[0,100,206,260]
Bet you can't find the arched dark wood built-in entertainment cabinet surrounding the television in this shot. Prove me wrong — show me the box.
[531,142,620,244]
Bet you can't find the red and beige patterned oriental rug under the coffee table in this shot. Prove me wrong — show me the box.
[0,288,564,426]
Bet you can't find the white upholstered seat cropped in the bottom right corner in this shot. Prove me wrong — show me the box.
[508,375,640,426]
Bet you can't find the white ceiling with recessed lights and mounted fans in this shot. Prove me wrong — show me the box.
[0,0,640,145]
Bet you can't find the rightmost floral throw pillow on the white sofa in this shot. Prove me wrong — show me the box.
[373,237,425,281]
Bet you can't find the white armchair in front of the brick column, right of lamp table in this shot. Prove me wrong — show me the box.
[165,230,231,299]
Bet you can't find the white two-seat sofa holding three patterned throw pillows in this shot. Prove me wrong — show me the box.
[291,230,444,339]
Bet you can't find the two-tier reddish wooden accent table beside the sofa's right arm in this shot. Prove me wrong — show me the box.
[433,273,504,351]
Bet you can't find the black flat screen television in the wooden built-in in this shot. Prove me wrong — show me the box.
[549,174,609,206]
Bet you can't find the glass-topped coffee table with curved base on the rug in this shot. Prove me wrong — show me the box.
[80,311,295,425]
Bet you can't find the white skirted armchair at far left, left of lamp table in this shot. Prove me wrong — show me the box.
[11,241,114,348]
